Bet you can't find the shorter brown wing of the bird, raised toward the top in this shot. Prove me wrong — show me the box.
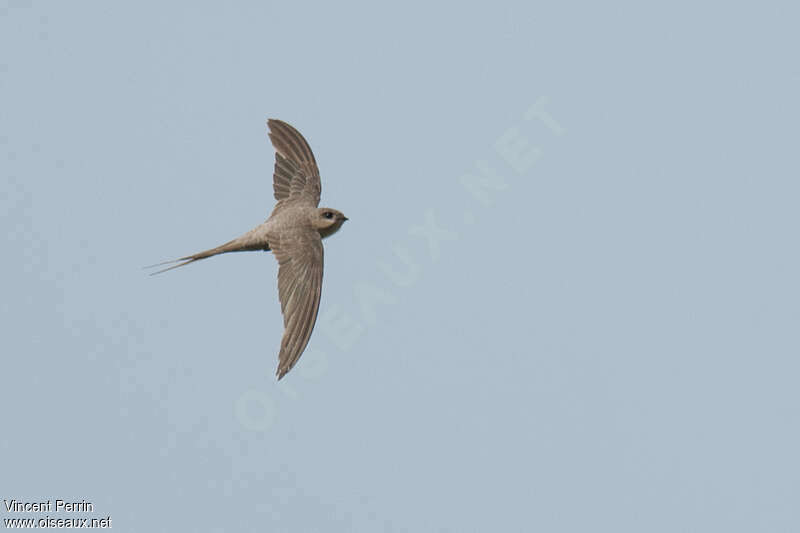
[267,118,322,207]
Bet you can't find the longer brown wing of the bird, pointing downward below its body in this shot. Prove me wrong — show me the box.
[270,229,323,379]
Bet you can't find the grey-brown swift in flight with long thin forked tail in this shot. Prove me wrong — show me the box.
[152,119,347,380]
